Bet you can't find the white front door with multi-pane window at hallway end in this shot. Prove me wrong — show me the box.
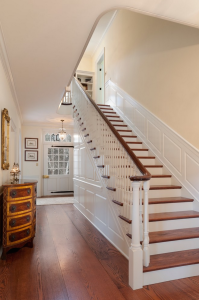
[43,145,73,196]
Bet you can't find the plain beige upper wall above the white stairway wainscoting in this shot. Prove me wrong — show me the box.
[92,10,199,149]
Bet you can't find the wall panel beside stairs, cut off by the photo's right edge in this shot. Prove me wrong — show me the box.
[185,153,199,193]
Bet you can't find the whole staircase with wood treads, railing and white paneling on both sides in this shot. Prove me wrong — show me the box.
[73,79,199,289]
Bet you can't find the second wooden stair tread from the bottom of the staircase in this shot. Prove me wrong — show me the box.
[149,227,199,244]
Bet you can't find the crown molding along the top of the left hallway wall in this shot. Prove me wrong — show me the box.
[0,24,23,123]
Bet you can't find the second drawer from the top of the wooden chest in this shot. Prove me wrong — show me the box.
[7,199,32,216]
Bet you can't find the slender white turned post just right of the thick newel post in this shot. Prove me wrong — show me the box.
[143,180,150,267]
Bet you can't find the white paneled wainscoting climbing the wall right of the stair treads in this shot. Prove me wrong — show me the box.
[105,80,199,206]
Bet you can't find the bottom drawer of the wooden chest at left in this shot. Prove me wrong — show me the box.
[7,225,32,246]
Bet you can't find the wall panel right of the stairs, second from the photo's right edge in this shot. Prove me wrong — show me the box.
[163,134,182,173]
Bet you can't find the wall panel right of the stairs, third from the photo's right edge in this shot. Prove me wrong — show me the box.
[147,120,161,152]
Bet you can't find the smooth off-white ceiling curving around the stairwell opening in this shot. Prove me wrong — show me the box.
[0,0,199,123]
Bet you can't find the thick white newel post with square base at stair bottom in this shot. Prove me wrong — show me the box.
[129,181,143,290]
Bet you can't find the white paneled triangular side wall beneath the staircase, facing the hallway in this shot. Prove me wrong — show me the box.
[74,142,129,258]
